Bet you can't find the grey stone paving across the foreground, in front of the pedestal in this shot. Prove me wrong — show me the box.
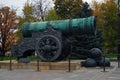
[0,63,120,80]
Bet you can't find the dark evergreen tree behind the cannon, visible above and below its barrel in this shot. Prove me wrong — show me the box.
[70,2,103,57]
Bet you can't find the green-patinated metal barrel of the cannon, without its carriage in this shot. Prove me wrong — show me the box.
[22,16,96,37]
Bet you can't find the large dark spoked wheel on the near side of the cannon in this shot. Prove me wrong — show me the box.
[36,35,62,61]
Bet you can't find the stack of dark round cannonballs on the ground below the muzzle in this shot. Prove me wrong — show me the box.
[82,48,110,67]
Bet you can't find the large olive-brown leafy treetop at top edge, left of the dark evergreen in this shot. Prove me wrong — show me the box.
[54,0,82,19]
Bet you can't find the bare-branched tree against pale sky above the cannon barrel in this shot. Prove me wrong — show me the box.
[33,0,51,21]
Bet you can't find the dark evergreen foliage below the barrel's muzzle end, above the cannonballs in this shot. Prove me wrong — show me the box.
[73,30,102,53]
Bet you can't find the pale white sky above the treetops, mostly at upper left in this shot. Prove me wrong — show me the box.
[0,0,103,15]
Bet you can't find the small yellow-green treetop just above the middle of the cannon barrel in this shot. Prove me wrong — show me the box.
[45,9,61,21]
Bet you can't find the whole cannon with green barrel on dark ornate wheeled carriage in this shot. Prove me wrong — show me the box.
[11,16,96,61]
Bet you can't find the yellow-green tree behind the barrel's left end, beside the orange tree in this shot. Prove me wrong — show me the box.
[17,1,38,42]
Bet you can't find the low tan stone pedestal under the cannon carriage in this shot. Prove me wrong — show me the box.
[0,60,81,70]
